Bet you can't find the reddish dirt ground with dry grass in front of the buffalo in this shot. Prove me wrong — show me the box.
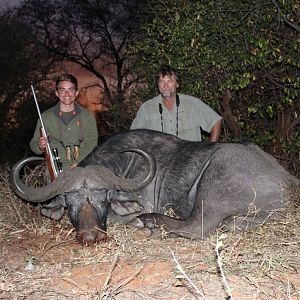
[0,170,300,300]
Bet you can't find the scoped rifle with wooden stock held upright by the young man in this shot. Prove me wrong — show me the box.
[31,85,62,181]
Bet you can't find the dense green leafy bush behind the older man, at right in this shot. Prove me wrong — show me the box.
[132,0,300,152]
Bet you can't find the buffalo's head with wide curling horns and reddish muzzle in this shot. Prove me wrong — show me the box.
[10,148,156,244]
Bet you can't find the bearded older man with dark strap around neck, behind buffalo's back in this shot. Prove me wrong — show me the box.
[130,66,222,142]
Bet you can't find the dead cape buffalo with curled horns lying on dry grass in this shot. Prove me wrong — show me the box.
[11,130,300,244]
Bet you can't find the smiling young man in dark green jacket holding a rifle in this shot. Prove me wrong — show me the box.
[30,74,98,220]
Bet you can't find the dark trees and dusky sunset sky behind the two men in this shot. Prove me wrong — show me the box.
[0,0,300,174]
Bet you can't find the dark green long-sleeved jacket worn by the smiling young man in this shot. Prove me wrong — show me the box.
[30,103,98,170]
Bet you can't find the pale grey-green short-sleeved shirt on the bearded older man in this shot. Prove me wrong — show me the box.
[130,94,222,141]
